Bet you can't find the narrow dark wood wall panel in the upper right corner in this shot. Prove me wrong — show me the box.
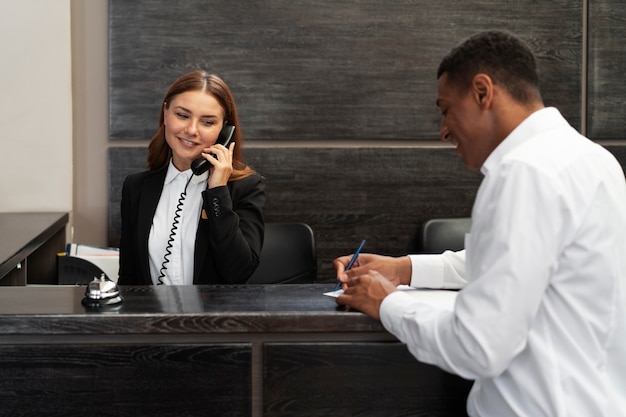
[587,0,626,140]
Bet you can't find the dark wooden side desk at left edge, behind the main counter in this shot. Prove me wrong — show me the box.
[0,213,69,285]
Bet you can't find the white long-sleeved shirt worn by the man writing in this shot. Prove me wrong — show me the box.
[380,108,626,417]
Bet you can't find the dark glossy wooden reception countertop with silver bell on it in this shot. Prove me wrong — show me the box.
[0,284,392,334]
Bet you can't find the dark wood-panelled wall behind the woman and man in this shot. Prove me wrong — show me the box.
[109,0,626,281]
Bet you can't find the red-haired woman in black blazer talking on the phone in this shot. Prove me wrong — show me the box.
[118,71,265,285]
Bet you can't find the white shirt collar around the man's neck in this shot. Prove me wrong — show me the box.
[480,107,567,175]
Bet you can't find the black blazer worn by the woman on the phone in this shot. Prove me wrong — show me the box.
[118,166,265,285]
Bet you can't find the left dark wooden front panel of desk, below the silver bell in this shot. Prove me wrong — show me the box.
[0,344,252,417]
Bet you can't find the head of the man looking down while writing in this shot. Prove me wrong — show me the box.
[437,31,543,169]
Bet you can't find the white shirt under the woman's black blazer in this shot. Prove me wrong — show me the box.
[148,161,208,285]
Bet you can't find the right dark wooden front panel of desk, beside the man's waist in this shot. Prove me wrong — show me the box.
[263,343,471,417]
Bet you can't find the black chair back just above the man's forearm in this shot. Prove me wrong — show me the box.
[418,217,472,253]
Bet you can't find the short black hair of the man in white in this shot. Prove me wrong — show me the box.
[437,30,541,103]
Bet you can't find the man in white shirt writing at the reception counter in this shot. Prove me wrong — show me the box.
[335,31,626,417]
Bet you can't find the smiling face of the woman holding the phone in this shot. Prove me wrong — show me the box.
[163,91,224,171]
